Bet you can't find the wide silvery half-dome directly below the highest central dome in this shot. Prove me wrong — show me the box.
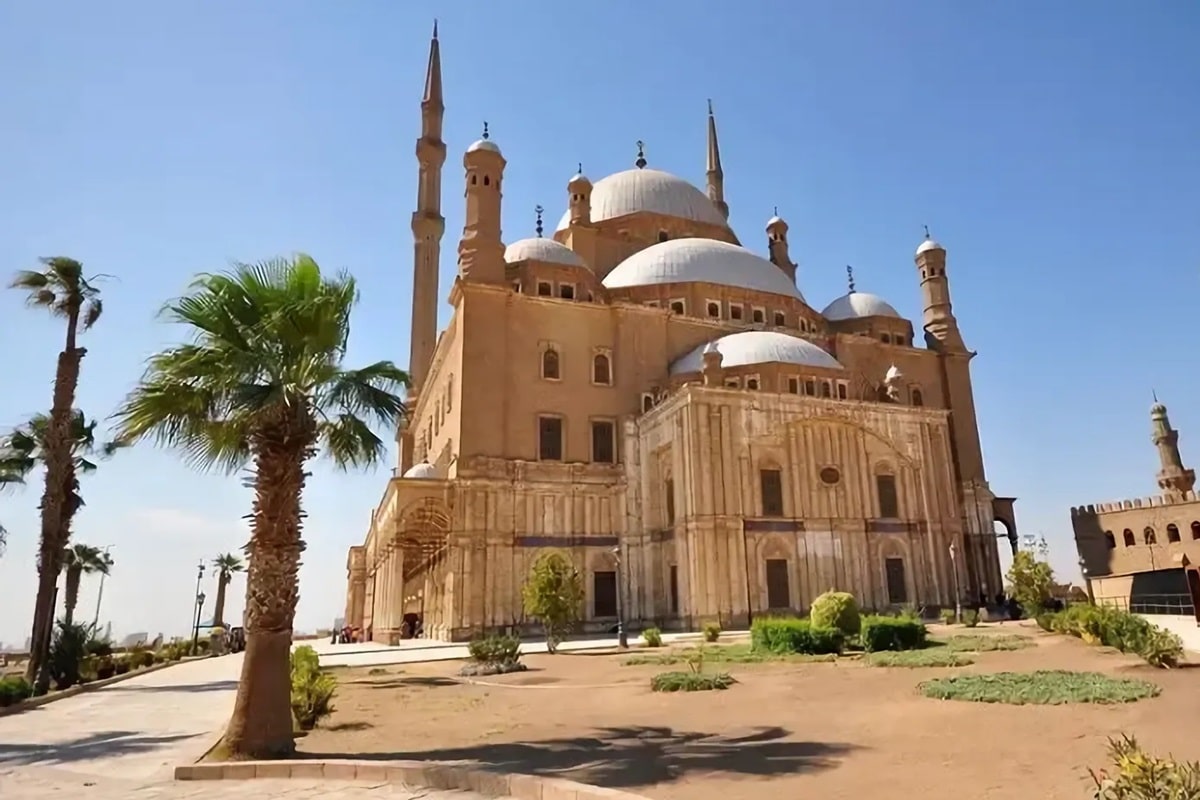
[604,239,804,301]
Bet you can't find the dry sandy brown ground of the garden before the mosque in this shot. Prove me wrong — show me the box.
[299,625,1200,800]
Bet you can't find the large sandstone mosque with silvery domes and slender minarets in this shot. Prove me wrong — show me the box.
[346,23,1016,643]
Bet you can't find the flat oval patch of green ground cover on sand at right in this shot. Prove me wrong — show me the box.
[918,669,1163,705]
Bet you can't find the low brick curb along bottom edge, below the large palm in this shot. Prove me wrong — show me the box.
[175,760,647,800]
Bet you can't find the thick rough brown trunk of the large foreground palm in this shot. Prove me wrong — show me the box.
[223,426,310,759]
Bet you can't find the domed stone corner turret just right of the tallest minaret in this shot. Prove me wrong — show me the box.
[458,122,506,284]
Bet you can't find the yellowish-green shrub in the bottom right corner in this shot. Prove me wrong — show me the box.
[1090,735,1200,800]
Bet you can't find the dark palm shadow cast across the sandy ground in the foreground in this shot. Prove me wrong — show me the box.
[299,727,858,788]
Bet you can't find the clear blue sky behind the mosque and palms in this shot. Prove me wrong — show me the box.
[0,0,1200,643]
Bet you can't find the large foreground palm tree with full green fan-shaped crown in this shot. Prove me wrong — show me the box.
[116,254,408,758]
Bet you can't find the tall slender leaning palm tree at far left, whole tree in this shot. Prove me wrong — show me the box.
[12,255,103,687]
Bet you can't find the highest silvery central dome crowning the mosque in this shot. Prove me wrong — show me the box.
[558,169,728,230]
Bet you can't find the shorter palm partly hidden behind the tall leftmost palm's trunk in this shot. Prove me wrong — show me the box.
[0,409,120,681]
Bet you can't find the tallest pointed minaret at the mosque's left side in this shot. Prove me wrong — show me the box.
[408,22,446,397]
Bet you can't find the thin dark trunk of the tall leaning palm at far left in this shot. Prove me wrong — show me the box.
[25,331,84,693]
